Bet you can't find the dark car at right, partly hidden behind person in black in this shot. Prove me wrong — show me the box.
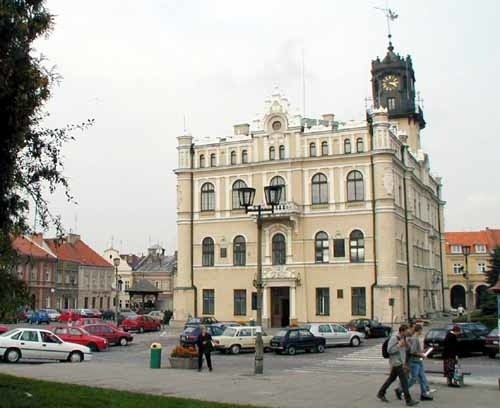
[424,328,485,356]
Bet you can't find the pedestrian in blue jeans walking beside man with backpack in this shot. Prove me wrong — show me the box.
[395,324,434,401]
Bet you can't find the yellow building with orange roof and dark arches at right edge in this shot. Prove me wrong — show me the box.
[445,228,500,309]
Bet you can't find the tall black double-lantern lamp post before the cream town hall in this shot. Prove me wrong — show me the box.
[238,186,281,374]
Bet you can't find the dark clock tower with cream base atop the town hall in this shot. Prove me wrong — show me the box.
[371,41,425,151]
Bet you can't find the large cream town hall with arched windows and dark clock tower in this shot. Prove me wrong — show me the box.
[174,44,446,326]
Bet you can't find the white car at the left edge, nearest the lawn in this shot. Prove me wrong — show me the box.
[0,328,92,363]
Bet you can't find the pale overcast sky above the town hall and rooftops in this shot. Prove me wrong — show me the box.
[36,0,500,254]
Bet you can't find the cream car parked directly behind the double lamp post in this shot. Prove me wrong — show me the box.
[213,326,273,354]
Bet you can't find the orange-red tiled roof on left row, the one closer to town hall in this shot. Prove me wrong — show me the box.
[45,238,112,268]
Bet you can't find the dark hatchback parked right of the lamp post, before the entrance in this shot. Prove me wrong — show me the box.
[270,328,326,356]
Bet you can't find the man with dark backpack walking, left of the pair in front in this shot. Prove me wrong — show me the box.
[377,324,418,407]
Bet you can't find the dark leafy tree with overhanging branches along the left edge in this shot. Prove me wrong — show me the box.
[0,0,92,316]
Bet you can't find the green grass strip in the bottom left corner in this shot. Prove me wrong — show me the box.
[0,374,260,408]
